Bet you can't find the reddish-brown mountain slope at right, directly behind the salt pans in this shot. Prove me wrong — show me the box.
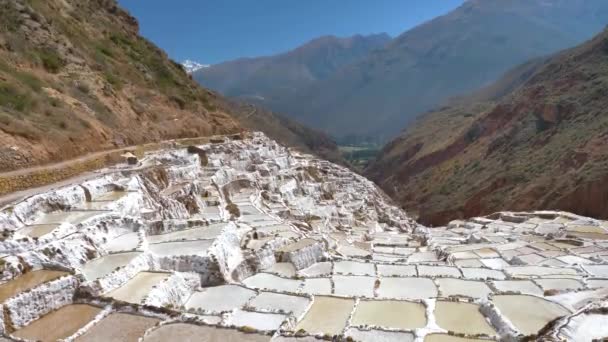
[366,26,608,224]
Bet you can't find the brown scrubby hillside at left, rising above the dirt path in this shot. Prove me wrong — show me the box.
[0,0,342,171]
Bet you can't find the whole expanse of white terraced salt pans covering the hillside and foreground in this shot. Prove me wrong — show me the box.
[0,133,608,341]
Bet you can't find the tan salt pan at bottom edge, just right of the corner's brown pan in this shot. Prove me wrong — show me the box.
[76,313,160,342]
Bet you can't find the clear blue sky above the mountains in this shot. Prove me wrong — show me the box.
[118,0,463,64]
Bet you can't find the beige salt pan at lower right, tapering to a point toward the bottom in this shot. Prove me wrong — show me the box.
[492,295,570,335]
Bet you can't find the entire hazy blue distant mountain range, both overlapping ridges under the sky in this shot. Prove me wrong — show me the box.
[194,0,608,139]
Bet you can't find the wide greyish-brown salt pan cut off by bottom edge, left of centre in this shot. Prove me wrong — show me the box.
[144,323,270,342]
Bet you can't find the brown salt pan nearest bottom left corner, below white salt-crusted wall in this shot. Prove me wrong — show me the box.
[13,304,101,342]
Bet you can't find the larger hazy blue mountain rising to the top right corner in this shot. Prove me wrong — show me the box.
[236,0,608,139]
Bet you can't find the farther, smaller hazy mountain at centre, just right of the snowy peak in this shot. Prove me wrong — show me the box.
[194,33,390,105]
